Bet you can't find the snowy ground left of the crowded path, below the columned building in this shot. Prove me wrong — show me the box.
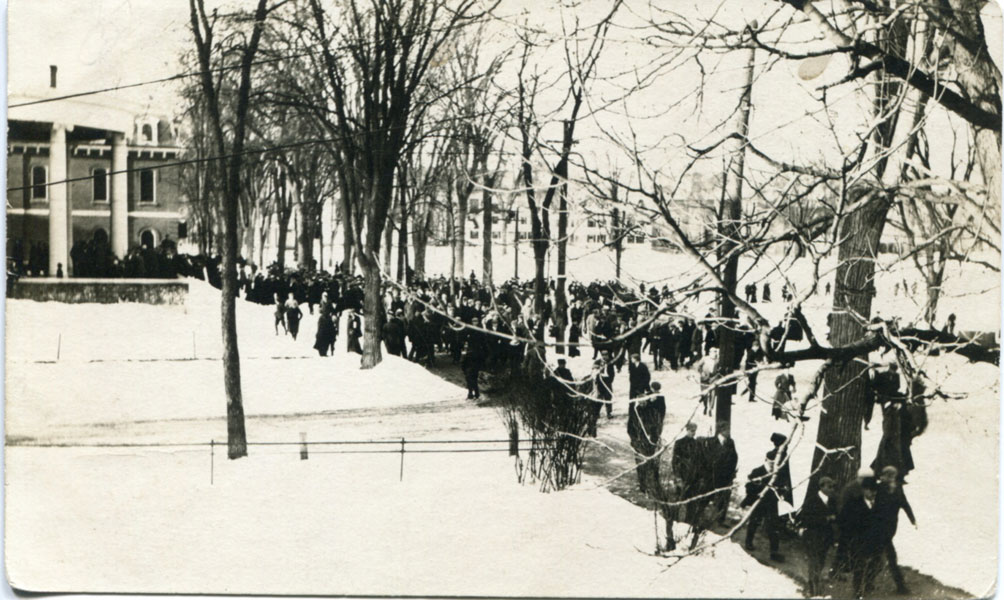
[6,284,797,597]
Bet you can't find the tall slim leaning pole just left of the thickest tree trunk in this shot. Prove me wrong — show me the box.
[715,36,755,424]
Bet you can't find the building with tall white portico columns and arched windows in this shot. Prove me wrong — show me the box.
[7,68,187,276]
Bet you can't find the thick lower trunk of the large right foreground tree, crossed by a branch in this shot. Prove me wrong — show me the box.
[809,193,890,494]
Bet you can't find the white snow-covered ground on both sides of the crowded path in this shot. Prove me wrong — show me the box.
[5,250,1000,597]
